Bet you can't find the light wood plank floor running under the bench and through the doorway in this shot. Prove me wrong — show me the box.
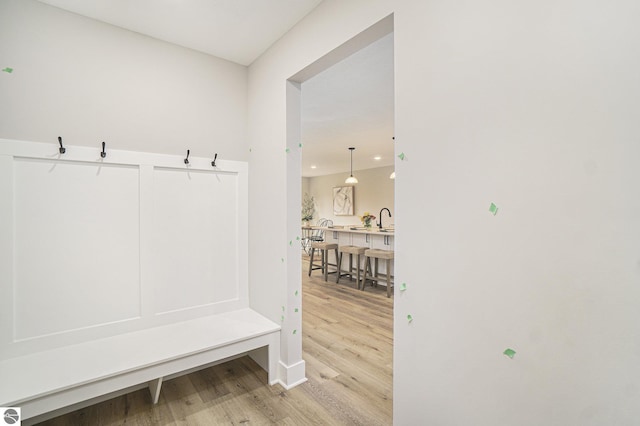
[41,257,393,426]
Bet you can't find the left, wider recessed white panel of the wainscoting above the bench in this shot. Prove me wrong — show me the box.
[13,157,140,340]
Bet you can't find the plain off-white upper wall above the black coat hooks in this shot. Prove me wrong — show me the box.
[0,0,248,161]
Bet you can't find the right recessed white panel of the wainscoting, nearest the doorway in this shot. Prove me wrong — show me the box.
[152,168,239,313]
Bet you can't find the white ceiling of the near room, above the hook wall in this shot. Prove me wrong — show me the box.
[39,0,322,65]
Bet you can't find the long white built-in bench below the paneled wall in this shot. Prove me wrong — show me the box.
[0,309,280,424]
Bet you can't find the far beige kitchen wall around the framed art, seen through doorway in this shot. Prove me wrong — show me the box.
[306,166,395,226]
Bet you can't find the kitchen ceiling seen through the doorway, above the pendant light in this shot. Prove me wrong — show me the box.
[302,33,394,177]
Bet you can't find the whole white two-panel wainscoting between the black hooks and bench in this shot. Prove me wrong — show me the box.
[0,139,248,358]
